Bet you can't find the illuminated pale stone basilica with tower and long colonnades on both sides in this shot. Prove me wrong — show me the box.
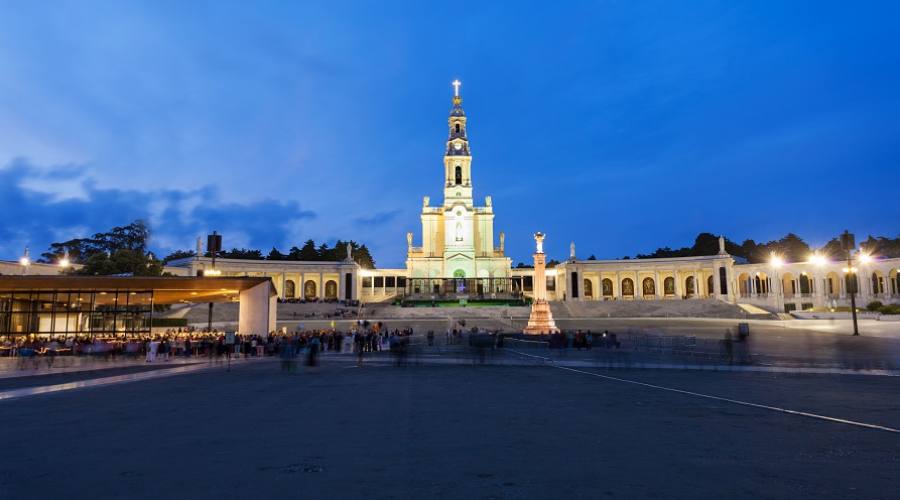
[149,81,900,312]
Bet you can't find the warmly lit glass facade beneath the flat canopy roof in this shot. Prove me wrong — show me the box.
[0,290,153,338]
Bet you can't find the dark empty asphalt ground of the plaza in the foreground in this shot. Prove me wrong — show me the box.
[0,358,900,499]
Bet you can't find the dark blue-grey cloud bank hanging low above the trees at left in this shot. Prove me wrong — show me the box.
[0,158,316,258]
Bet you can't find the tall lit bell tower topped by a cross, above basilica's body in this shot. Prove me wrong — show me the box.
[444,80,472,207]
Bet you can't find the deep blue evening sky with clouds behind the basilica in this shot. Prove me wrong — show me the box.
[0,0,900,267]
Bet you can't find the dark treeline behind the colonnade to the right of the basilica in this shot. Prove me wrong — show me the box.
[625,233,900,263]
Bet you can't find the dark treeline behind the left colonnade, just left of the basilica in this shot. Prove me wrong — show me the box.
[163,239,375,269]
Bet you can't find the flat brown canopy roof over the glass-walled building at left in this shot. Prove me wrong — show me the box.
[0,275,275,304]
